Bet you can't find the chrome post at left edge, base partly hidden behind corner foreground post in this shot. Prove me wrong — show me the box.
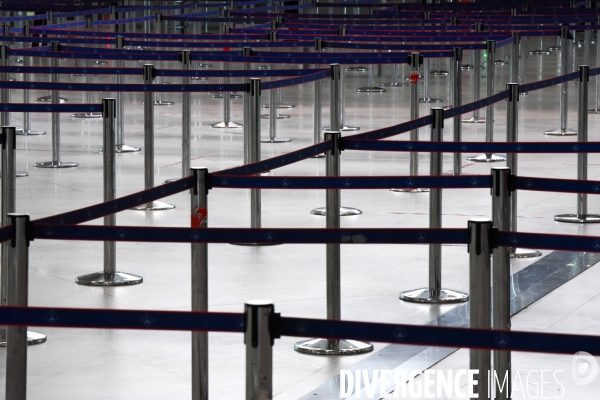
[0,126,46,347]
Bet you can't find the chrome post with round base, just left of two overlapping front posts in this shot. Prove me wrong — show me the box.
[400,107,469,303]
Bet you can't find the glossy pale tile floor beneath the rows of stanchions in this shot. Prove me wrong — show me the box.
[0,34,600,400]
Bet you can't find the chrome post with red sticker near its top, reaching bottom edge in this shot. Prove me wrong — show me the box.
[195,167,210,400]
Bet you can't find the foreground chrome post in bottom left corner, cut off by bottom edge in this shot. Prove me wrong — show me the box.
[6,213,33,400]
